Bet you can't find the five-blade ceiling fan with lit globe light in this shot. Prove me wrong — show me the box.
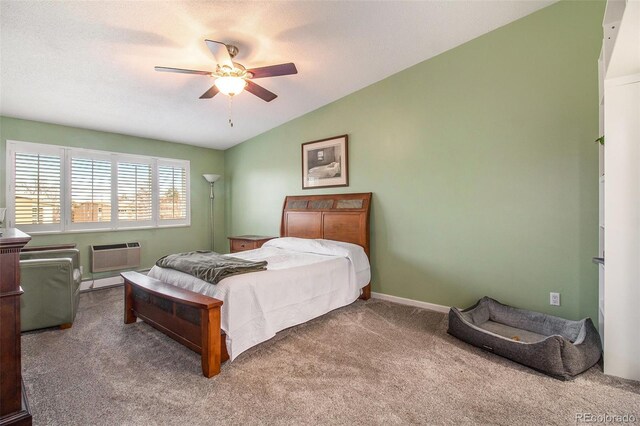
[155,40,298,102]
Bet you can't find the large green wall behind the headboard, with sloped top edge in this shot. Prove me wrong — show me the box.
[225,2,604,321]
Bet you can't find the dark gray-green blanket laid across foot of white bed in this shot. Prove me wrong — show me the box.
[156,251,267,284]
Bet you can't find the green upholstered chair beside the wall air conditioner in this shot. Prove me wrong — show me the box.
[20,249,82,331]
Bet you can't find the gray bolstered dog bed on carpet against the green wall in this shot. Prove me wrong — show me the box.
[448,297,602,379]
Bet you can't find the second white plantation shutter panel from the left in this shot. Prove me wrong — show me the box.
[71,156,112,224]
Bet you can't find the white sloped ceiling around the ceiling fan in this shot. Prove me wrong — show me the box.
[0,0,553,149]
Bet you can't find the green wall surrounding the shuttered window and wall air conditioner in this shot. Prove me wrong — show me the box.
[0,117,227,279]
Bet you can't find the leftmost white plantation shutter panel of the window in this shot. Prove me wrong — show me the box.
[13,152,62,230]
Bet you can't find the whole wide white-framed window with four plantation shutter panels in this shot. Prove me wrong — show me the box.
[7,141,191,233]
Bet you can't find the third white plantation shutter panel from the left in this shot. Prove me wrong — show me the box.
[118,162,153,223]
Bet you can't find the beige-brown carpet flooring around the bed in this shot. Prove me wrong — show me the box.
[22,288,640,425]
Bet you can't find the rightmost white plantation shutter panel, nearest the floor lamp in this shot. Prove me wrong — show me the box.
[158,164,188,220]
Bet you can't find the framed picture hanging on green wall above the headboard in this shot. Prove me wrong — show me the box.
[302,135,349,189]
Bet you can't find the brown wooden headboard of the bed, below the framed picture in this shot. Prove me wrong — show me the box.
[280,192,371,256]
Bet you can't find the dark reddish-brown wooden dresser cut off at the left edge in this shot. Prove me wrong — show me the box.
[0,228,31,426]
